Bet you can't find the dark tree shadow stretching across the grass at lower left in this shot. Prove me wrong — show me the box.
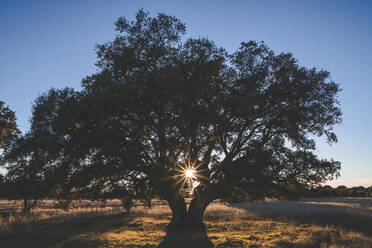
[0,213,132,248]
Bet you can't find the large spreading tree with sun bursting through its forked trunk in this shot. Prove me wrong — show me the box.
[10,10,341,228]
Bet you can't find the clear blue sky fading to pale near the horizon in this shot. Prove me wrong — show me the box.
[0,0,372,186]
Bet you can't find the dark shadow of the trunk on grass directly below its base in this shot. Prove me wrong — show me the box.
[158,228,214,248]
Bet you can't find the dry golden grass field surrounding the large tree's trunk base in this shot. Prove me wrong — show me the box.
[0,198,372,248]
